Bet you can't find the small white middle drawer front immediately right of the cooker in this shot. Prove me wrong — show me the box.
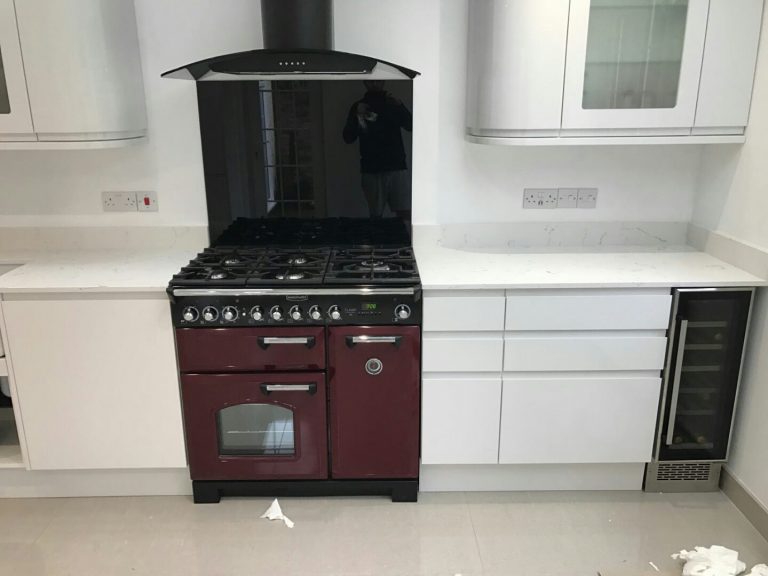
[422,332,504,372]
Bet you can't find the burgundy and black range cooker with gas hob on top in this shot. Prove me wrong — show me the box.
[169,247,421,502]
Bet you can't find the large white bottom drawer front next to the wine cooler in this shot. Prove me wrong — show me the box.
[499,377,661,464]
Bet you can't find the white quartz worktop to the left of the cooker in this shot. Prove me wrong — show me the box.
[0,248,197,294]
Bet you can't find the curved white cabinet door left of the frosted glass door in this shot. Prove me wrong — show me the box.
[467,0,569,136]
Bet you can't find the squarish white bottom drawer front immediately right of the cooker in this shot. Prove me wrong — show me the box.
[421,377,501,464]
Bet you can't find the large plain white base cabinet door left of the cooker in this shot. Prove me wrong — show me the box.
[2,295,186,470]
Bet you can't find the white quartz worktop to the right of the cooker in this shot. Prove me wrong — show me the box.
[413,228,766,290]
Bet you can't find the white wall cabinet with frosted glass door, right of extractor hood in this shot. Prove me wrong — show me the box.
[468,0,763,144]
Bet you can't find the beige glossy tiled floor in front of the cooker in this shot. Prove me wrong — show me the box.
[0,492,768,576]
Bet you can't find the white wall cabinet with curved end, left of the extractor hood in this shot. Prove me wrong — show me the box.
[0,0,147,148]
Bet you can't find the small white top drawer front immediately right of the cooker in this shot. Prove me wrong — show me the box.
[423,292,505,332]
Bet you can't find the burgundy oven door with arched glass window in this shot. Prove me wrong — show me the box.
[181,372,328,480]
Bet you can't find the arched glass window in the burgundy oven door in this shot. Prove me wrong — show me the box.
[216,404,296,456]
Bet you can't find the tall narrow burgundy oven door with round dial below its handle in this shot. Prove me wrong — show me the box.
[328,326,421,479]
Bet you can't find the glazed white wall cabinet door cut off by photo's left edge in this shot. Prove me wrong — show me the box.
[0,0,33,140]
